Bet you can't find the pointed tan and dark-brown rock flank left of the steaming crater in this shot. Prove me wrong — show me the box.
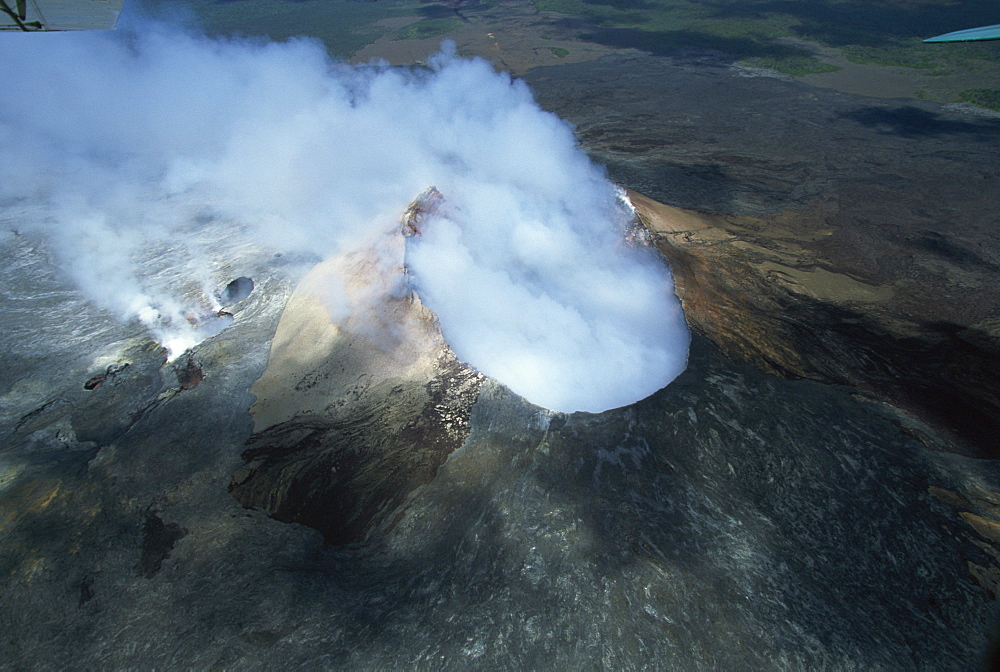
[230,189,483,544]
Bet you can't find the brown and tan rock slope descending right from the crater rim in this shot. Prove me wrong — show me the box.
[629,192,1000,458]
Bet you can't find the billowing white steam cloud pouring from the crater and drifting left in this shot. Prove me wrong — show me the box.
[0,25,688,411]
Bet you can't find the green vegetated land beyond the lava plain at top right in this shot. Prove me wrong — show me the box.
[533,0,1000,84]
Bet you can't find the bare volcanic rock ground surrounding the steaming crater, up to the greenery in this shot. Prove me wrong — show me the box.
[0,58,1000,670]
